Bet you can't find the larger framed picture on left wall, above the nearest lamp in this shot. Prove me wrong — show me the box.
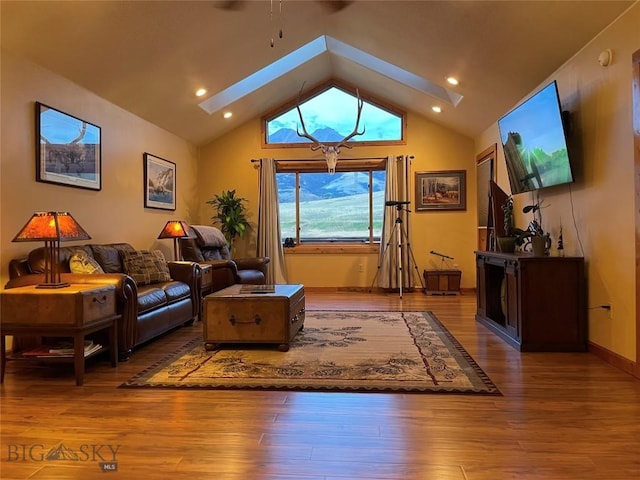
[36,102,102,190]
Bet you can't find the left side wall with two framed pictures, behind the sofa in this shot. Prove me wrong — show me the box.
[0,50,197,286]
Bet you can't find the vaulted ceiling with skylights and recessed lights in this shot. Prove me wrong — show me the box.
[0,0,635,145]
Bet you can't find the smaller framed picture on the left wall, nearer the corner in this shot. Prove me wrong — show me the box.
[144,152,176,210]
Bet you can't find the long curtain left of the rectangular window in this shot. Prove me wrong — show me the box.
[258,158,287,284]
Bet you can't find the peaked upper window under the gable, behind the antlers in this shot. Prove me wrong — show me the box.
[263,84,404,147]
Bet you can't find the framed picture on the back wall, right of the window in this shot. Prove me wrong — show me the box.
[415,170,467,212]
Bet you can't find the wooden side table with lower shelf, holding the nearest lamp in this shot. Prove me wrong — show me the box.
[0,284,120,385]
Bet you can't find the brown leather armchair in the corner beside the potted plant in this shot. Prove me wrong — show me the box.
[179,225,270,292]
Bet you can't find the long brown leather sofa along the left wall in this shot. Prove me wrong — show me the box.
[5,243,200,360]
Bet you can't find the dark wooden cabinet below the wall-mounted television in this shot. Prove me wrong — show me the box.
[476,251,587,352]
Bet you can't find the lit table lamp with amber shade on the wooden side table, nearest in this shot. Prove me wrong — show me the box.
[12,212,91,288]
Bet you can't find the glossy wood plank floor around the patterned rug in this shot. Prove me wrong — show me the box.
[0,291,640,480]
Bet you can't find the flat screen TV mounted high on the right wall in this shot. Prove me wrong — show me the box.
[498,81,574,195]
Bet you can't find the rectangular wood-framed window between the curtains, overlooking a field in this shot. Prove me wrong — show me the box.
[276,159,386,246]
